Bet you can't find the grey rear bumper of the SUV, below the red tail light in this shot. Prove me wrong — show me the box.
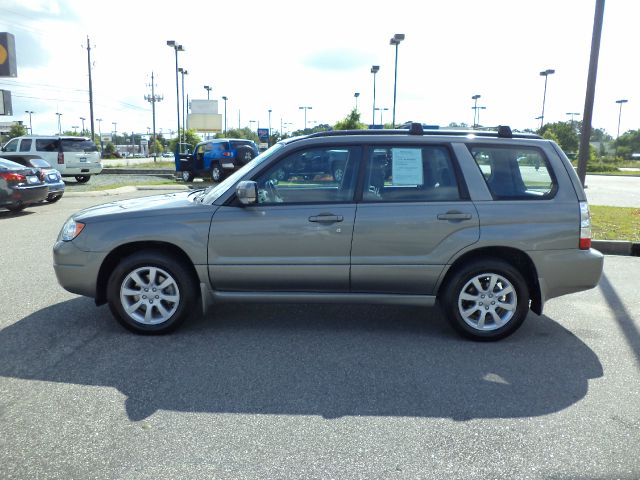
[529,248,604,305]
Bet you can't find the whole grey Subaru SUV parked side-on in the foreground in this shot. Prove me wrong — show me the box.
[53,124,603,340]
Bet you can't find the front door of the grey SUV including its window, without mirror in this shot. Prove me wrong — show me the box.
[208,147,360,293]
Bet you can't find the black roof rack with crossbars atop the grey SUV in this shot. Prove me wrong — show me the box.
[299,122,542,138]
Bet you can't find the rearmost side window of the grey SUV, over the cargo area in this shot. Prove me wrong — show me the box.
[470,145,557,200]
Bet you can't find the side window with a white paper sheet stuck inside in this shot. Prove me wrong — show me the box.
[362,146,460,202]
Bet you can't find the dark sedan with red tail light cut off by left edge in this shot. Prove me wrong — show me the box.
[0,158,49,212]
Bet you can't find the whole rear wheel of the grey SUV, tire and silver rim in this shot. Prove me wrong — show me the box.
[441,258,529,341]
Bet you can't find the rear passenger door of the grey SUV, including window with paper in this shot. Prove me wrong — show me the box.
[351,144,479,295]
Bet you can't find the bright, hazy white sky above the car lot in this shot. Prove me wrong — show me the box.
[0,0,640,137]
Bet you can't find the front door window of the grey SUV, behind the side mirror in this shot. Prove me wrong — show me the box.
[255,146,360,204]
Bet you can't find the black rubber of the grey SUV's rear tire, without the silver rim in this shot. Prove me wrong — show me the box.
[443,259,529,341]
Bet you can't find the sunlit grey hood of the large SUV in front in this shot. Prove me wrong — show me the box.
[73,192,200,222]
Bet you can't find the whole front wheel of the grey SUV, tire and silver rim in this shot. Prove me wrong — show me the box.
[107,250,198,334]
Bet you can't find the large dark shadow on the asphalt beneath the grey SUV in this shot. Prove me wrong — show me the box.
[0,298,603,421]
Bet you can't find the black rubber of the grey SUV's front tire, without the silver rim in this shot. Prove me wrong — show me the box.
[107,251,197,334]
